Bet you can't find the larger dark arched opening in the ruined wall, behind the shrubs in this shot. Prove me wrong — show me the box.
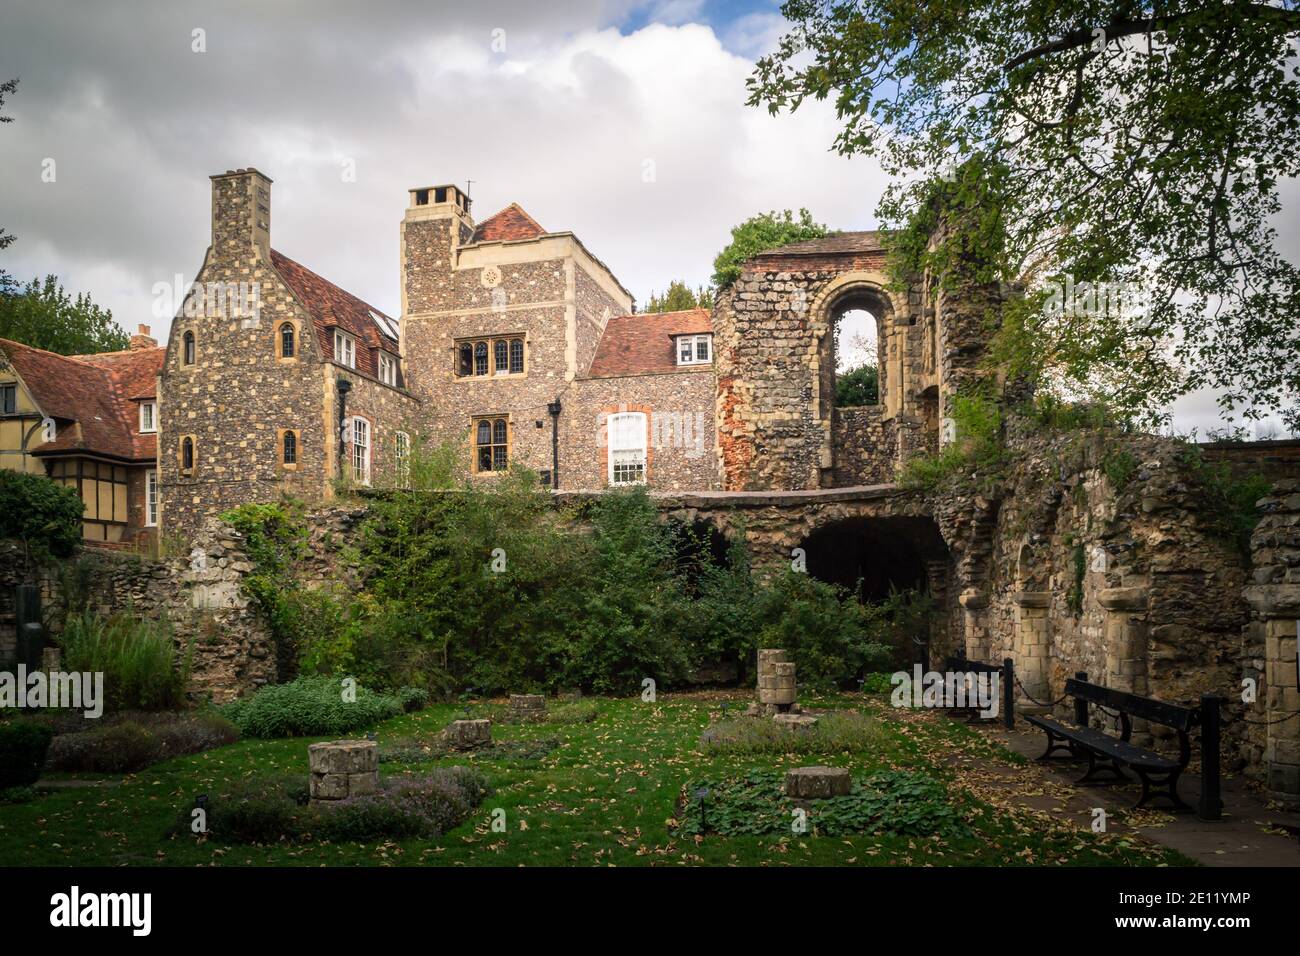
[801,516,949,666]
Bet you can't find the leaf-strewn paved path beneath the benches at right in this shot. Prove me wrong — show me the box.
[956,722,1300,866]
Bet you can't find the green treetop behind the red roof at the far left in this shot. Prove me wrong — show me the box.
[0,276,130,355]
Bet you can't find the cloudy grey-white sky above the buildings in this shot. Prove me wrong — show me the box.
[0,0,1289,431]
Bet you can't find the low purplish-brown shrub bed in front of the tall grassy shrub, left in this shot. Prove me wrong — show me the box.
[47,714,239,774]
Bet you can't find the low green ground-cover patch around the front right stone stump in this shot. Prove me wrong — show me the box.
[679,770,970,836]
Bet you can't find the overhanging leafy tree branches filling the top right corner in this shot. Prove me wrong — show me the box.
[750,0,1300,423]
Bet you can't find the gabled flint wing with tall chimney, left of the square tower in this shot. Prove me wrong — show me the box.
[159,169,420,536]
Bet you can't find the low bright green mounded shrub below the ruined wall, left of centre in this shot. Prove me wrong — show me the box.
[222,676,402,737]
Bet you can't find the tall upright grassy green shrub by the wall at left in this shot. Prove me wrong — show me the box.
[60,610,190,710]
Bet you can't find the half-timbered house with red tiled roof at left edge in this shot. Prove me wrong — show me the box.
[0,325,163,545]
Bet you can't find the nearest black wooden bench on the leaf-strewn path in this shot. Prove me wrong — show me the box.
[1024,678,1201,813]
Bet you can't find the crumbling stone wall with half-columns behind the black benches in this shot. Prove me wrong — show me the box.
[933,425,1262,767]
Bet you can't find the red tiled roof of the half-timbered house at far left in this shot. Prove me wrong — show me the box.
[0,339,164,460]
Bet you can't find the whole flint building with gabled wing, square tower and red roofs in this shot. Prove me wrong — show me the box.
[149,169,718,536]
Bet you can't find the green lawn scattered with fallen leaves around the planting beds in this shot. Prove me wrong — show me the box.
[0,693,1188,866]
